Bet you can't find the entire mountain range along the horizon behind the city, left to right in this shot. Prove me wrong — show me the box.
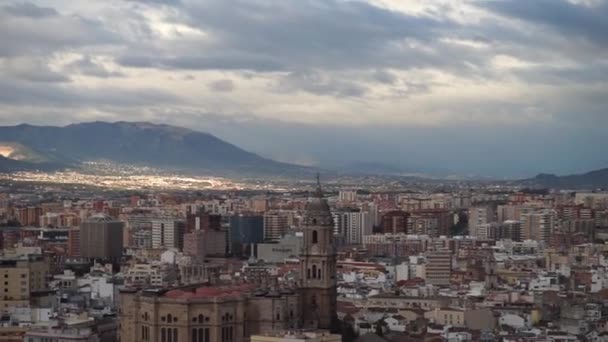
[0,121,608,189]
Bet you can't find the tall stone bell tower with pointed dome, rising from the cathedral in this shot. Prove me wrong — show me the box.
[299,174,337,330]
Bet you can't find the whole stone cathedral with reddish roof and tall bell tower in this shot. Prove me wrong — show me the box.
[119,182,337,342]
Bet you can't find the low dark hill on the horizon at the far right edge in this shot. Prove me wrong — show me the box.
[522,169,608,189]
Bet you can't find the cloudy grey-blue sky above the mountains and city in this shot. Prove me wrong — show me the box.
[0,0,608,178]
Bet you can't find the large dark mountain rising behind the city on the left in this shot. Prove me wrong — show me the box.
[0,122,313,176]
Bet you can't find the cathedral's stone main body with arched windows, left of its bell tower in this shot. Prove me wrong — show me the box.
[120,285,299,342]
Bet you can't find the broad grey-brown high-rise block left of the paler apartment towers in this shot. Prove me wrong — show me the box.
[80,214,124,259]
